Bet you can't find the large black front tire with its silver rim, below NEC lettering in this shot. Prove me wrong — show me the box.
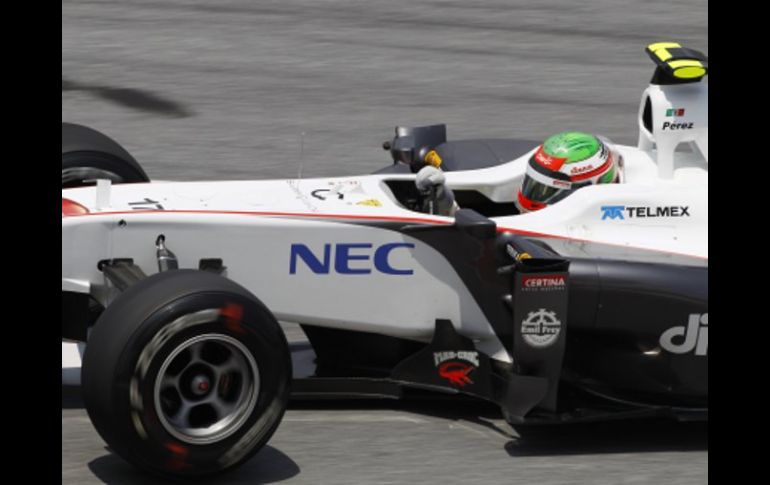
[82,270,292,479]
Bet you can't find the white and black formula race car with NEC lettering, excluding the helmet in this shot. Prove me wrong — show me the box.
[62,43,708,477]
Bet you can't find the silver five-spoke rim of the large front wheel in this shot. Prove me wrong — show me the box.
[154,334,260,444]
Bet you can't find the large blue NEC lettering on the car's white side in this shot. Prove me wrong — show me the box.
[289,243,414,276]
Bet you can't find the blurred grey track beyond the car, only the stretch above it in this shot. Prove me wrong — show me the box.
[62,0,708,180]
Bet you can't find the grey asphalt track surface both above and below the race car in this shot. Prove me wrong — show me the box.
[62,0,708,485]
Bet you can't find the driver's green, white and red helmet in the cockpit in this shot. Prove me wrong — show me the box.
[516,131,621,213]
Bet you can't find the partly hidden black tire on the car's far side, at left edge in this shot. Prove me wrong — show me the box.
[61,123,150,189]
